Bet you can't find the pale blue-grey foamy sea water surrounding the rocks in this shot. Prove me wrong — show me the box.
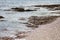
[0,0,60,37]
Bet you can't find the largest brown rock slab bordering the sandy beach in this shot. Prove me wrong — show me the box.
[28,16,57,25]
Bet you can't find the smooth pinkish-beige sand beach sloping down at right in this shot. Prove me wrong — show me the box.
[25,18,60,40]
